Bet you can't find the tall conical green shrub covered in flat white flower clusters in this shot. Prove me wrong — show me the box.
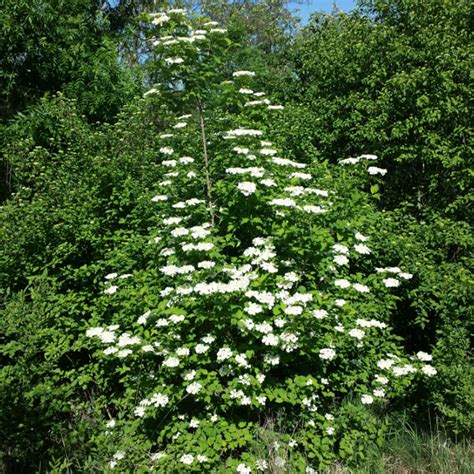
[79,9,436,474]
